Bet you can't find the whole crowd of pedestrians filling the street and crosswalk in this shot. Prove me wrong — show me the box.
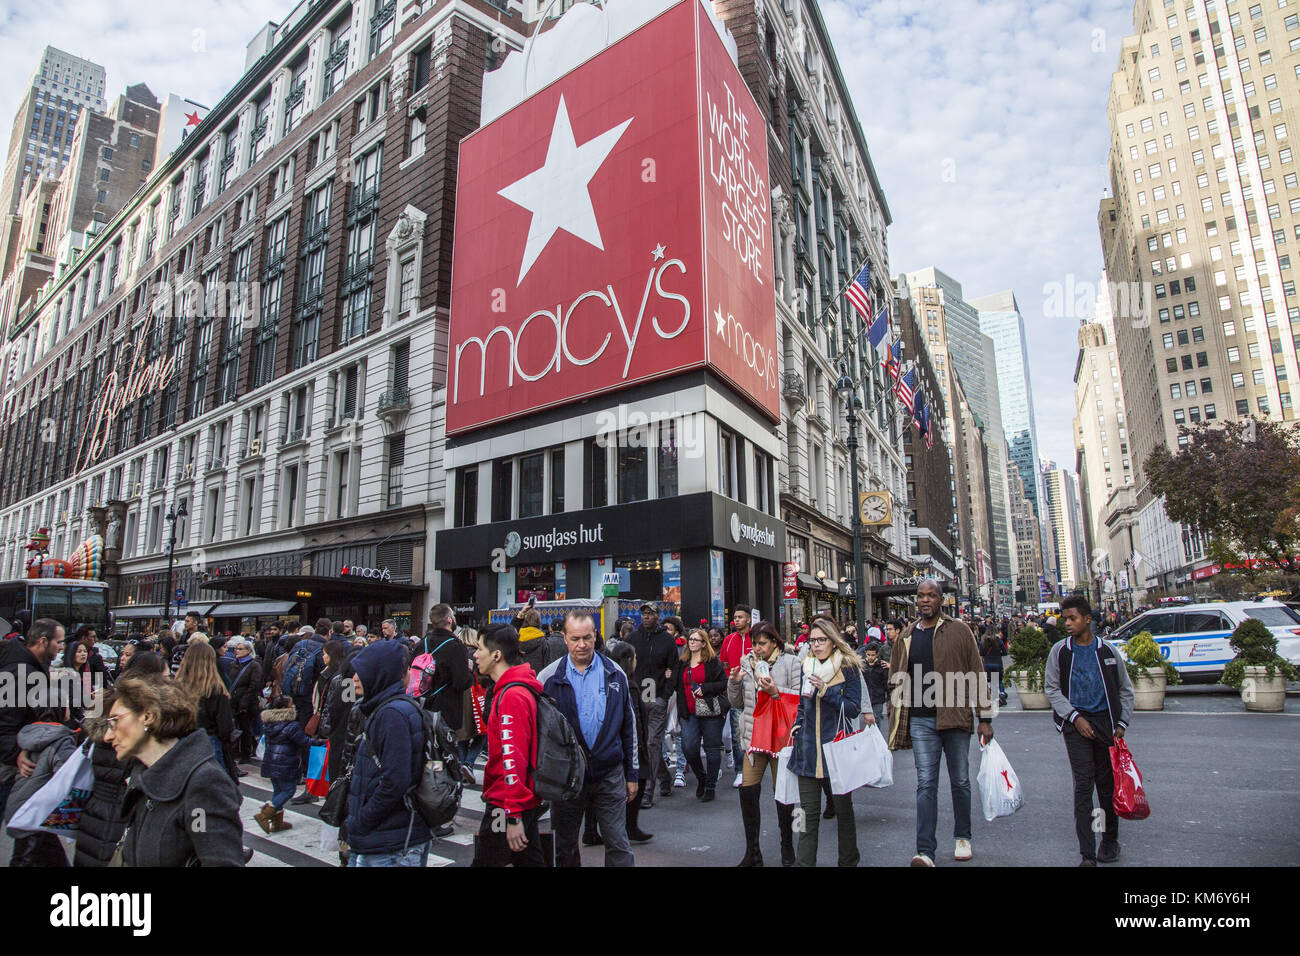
[0,581,1132,866]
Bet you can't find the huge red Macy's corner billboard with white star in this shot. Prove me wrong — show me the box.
[447,0,780,434]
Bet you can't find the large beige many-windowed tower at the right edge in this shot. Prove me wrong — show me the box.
[1099,0,1300,589]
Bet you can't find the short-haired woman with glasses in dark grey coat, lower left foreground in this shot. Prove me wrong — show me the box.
[104,671,244,866]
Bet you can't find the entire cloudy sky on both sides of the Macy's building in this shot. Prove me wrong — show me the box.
[0,0,1132,476]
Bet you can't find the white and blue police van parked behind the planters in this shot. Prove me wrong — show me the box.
[1109,601,1300,683]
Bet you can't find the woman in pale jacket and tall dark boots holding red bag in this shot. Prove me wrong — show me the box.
[727,620,800,866]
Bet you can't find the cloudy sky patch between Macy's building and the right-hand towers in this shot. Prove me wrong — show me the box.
[822,0,1132,468]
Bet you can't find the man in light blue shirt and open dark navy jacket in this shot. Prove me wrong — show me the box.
[540,611,638,866]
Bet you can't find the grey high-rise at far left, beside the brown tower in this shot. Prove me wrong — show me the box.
[0,47,104,216]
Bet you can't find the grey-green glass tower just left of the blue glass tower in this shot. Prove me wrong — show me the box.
[905,267,1015,590]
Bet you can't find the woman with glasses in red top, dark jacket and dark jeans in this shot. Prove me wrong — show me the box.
[670,627,727,804]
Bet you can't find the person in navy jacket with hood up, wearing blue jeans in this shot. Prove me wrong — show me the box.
[347,641,433,866]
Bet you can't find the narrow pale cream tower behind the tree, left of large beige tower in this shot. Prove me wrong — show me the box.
[1074,277,1135,587]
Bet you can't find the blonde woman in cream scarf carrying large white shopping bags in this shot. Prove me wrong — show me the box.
[789,618,875,866]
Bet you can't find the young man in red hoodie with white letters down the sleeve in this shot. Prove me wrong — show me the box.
[473,627,546,866]
